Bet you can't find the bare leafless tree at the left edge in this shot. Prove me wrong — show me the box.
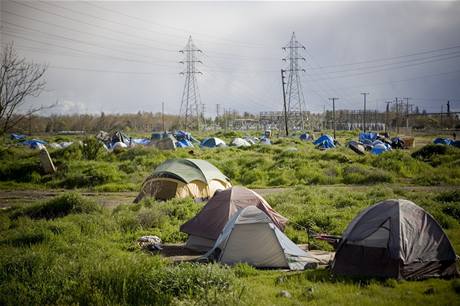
[0,43,47,134]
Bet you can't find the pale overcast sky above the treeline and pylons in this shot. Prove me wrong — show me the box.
[0,0,460,116]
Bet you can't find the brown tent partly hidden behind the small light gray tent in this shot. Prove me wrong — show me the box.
[180,186,287,251]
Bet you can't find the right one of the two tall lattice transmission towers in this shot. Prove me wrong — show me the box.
[283,32,306,129]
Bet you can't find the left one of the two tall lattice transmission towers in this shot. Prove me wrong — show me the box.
[179,36,202,130]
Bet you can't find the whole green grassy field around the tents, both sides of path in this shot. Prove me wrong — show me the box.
[0,133,460,305]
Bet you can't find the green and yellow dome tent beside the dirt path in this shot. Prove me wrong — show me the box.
[134,159,232,203]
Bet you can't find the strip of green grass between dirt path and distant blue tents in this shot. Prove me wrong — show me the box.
[0,132,460,192]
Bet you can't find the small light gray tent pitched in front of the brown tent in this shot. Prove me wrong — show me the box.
[203,206,326,270]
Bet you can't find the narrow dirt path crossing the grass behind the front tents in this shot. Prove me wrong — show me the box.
[0,184,460,208]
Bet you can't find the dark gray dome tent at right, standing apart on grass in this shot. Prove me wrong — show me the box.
[332,200,458,279]
